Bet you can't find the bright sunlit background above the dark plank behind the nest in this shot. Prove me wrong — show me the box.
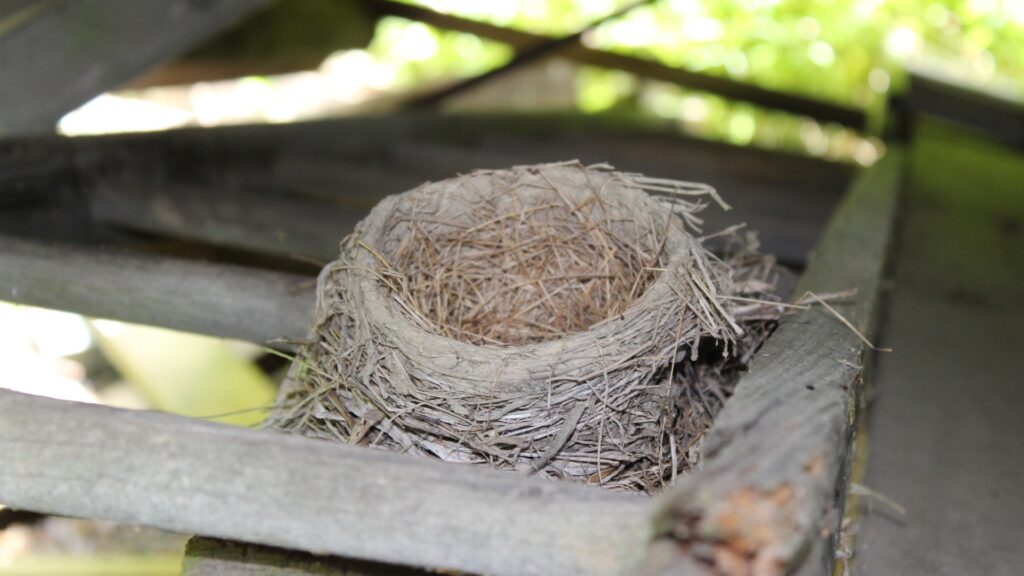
[59,0,1024,165]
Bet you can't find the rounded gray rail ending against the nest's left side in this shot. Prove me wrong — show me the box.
[0,237,315,342]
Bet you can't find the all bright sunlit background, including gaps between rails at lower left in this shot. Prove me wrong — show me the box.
[0,0,1024,574]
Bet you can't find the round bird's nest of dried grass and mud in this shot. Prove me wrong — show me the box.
[271,162,779,491]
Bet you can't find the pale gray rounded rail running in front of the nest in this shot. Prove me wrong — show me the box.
[0,389,652,576]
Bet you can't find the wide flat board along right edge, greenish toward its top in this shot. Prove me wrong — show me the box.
[847,120,1024,576]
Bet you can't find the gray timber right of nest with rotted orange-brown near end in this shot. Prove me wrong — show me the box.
[646,150,903,575]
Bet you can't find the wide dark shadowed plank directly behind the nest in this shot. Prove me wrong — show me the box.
[59,115,853,265]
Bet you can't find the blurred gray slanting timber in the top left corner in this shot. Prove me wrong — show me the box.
[0,0,265,133]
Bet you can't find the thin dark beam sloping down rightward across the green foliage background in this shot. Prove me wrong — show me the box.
[374,0,867,129]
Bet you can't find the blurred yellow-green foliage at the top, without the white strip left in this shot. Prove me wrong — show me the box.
[378,0,1024,162]
